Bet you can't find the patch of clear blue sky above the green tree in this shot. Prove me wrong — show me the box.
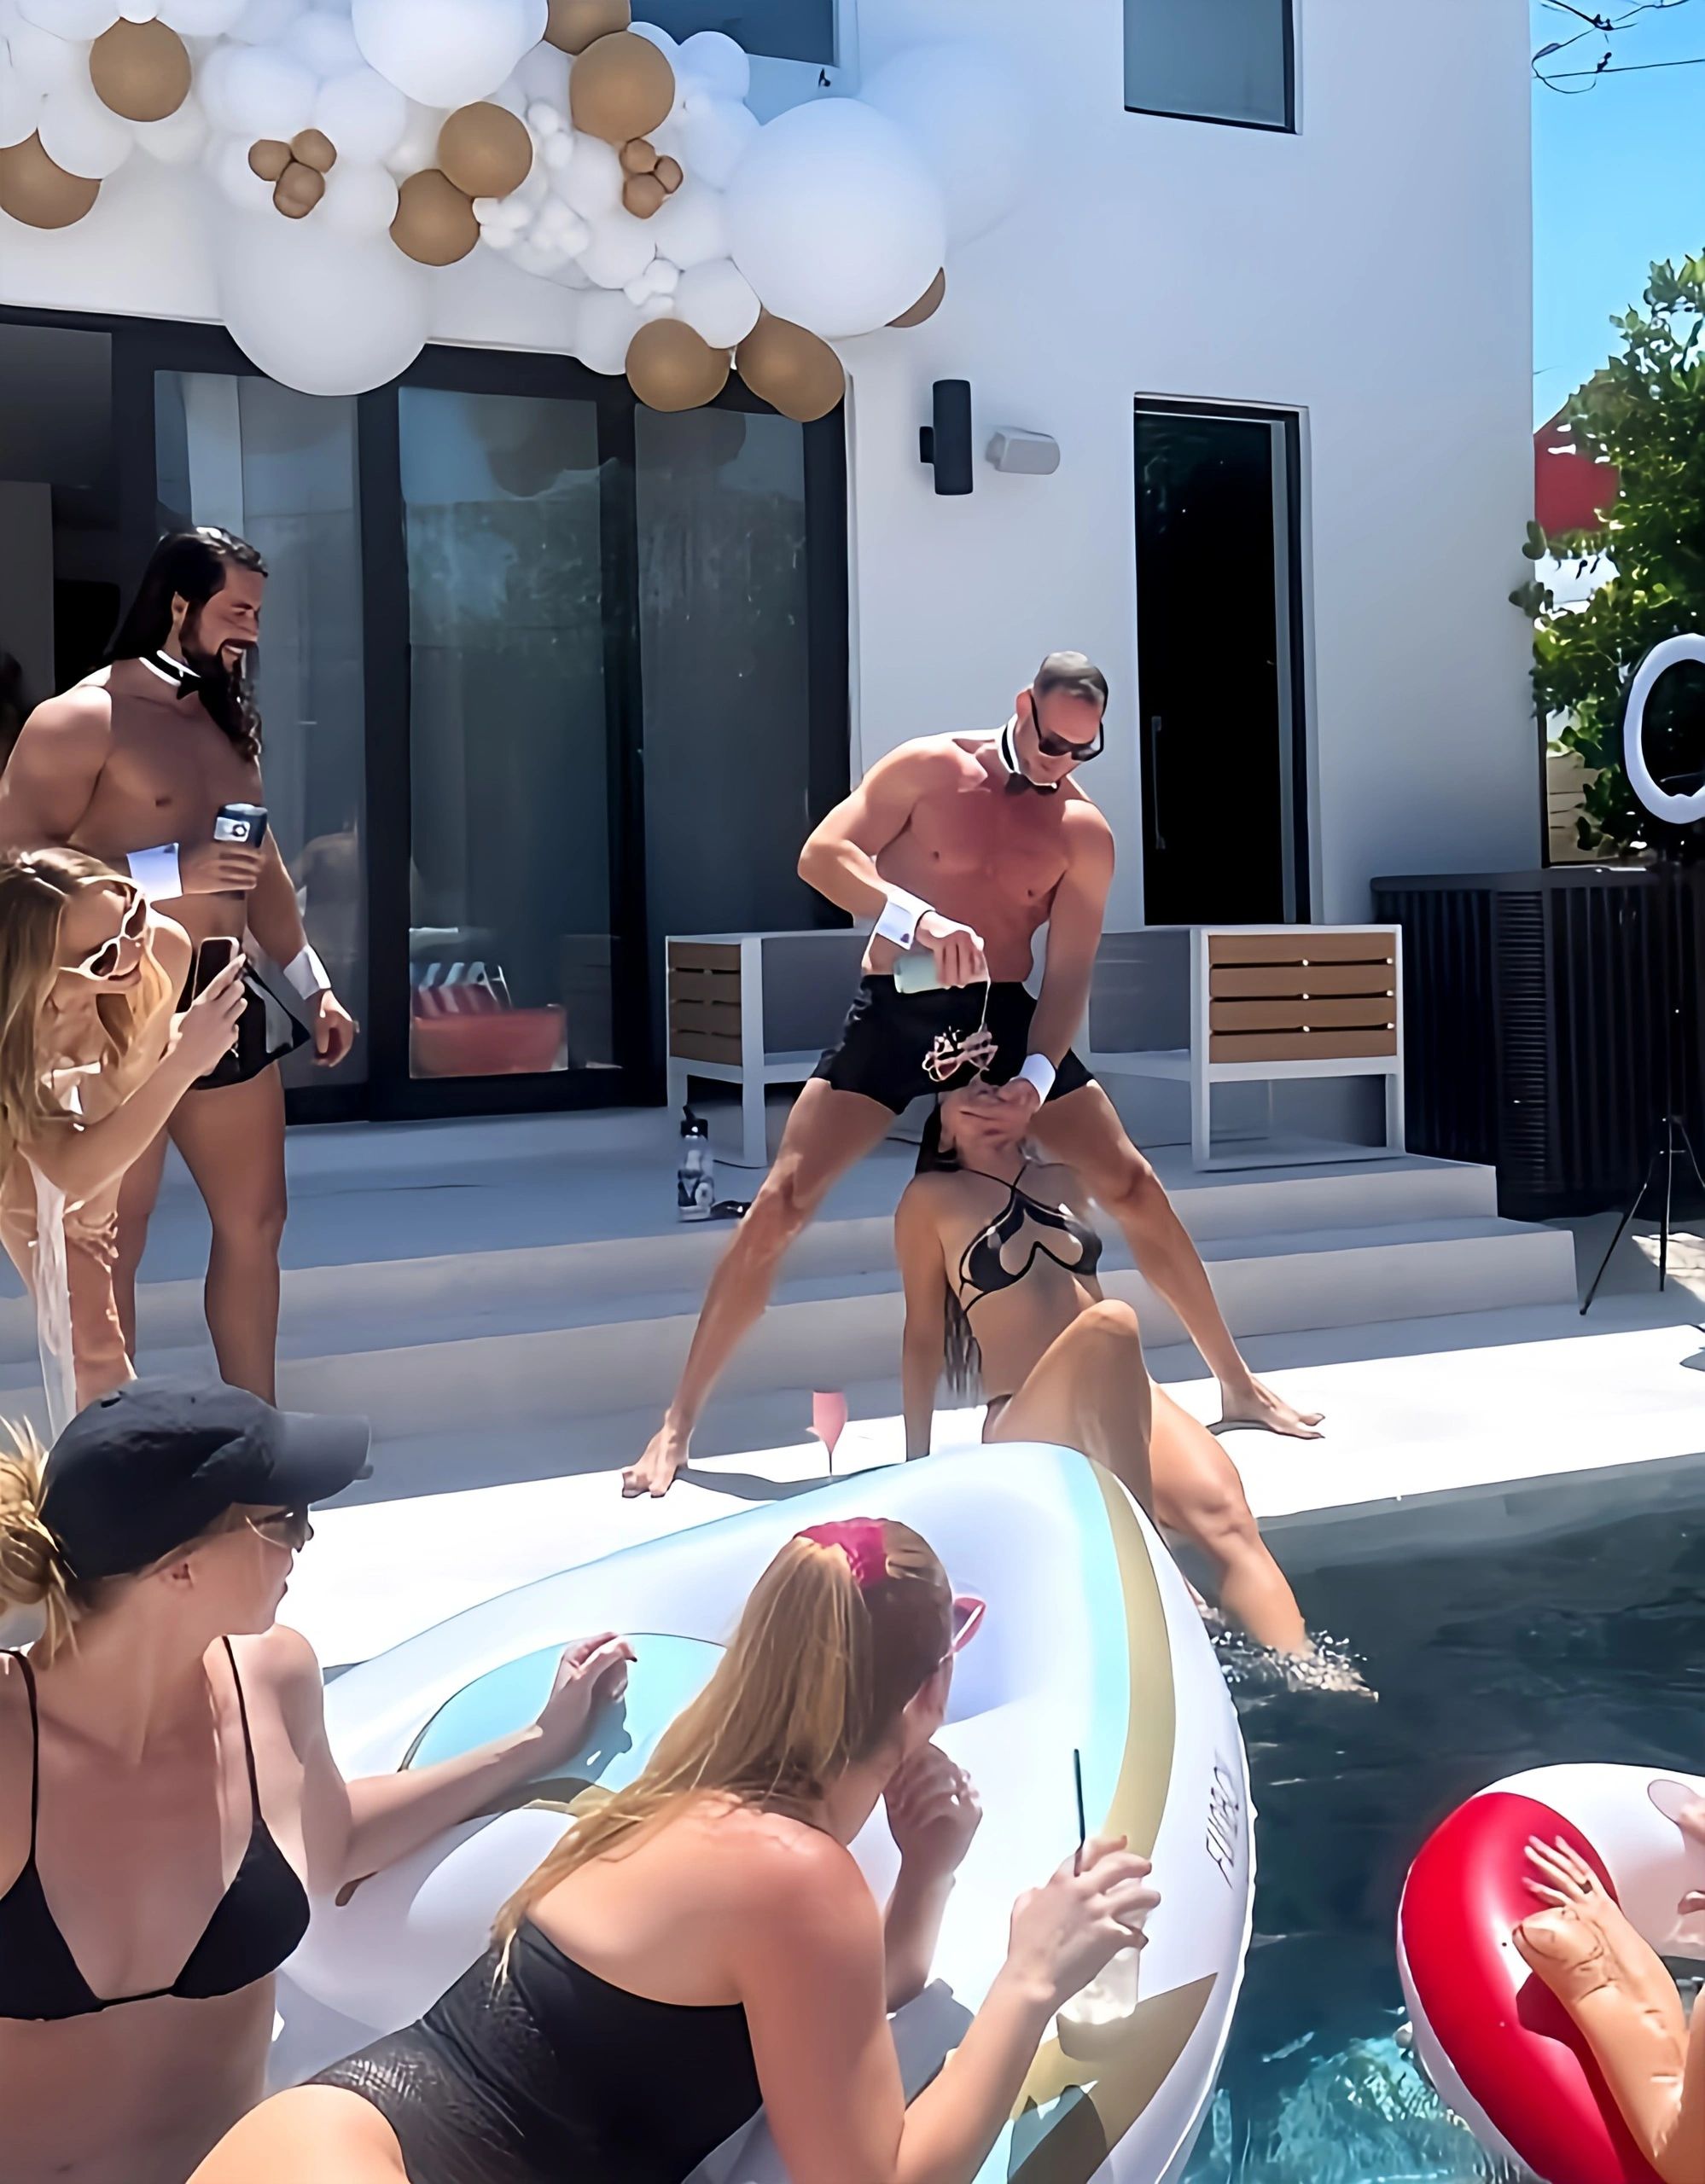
[1530,0,1705,424]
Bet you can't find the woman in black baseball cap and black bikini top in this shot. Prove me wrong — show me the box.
[0,1380,631,2184]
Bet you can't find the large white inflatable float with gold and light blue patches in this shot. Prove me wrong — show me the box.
[277,1446,1254,2184]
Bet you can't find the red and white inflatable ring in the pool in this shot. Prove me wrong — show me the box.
[1397,1767,1705,2184]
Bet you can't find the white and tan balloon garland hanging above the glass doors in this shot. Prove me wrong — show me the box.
[0,0,1023,421]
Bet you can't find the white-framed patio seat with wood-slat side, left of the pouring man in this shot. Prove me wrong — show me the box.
[665,926,865,1169]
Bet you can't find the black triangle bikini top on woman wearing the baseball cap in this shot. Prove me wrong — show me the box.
[0,1638,308,2020]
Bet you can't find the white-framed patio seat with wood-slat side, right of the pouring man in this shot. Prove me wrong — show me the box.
[1085,926,1404,1169]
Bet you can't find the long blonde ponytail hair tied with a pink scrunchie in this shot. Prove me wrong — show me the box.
[496,1520,953,1943]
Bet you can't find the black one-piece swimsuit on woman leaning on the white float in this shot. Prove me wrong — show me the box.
[311,1920,760,2184]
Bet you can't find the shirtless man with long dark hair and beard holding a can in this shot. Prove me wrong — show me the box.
[0,531,357,1403]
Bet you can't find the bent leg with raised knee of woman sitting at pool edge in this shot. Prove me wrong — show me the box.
[984,1299,1162,1516]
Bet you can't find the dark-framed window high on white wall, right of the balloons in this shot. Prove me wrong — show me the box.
[1126,0,1296,129]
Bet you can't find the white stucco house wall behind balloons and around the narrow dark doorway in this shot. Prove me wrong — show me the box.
[0,0,1541,924]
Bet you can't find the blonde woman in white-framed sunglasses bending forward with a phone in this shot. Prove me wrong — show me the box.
[0,850,242,1432]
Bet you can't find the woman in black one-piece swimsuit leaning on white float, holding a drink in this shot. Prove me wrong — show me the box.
[192,1518,1159,2184]
